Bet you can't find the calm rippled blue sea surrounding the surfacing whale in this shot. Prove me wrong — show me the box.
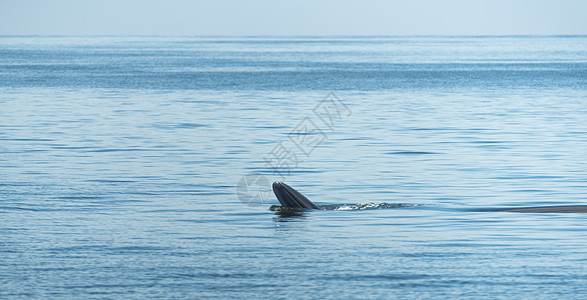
[0,36,587,299]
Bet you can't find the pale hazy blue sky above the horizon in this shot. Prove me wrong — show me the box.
[0,0,587,35]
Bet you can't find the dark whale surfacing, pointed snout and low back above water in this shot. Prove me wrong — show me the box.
[273,181,587,213]
